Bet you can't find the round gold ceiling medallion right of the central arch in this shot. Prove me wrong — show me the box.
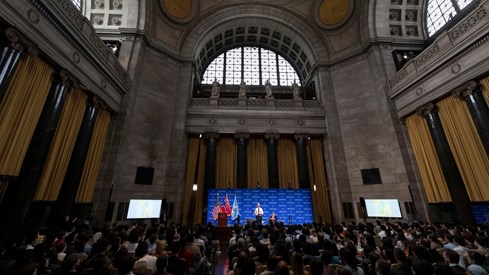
[313,0,354,29]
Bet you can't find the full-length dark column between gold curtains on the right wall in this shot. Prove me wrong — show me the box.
[418,103,475,225]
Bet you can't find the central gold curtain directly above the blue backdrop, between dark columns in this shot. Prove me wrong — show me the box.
[247,136,269,188]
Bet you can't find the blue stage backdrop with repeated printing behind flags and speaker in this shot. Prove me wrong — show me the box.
[207,188,314,225]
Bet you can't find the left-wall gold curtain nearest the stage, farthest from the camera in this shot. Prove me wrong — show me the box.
[75,110,110,203]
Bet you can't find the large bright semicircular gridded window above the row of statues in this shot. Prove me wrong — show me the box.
[202,47,301,86]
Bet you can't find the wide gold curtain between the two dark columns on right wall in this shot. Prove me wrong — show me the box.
[437,97,489,201]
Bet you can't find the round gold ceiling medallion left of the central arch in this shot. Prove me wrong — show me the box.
[160,0,198,24]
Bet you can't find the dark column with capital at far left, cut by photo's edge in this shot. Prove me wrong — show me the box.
[0,28,38,103]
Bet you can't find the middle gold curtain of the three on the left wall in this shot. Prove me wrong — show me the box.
[34,89,87,201]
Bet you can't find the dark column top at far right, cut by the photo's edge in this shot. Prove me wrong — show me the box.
[453,81,489,155]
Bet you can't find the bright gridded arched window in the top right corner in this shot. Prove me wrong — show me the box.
[426,0,473,36]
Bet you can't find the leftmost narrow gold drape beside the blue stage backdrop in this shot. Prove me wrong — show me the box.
[182,137,200,224]
